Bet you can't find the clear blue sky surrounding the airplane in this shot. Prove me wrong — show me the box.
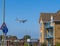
[0,0,60,39]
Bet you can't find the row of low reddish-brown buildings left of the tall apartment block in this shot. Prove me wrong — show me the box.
[0,35,39,46]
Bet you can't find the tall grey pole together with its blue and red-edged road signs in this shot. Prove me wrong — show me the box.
[1,0,8,46]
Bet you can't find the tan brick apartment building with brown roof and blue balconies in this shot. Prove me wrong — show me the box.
[39,10,60,46]
